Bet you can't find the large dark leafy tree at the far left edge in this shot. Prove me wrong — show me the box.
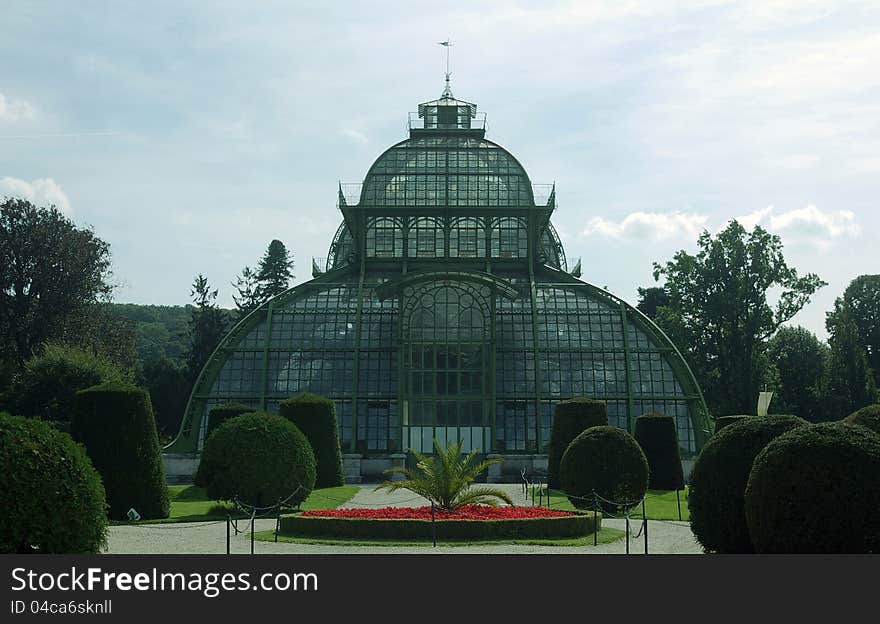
[0,198,112,370]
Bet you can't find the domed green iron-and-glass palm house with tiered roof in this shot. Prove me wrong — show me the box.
[165,85,708,482]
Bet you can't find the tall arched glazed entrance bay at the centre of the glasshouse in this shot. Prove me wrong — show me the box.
[402,282,491,453]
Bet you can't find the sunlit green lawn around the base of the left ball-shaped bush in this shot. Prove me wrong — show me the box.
[113,485,358,524]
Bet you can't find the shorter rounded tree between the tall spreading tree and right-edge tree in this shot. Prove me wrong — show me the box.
[768,327,828,422]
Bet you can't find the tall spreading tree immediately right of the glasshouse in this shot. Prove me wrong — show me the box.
[654,220,825,414]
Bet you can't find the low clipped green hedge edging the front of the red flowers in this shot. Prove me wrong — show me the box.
[280,512,602,540]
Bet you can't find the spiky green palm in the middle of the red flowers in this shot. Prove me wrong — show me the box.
[376,439,513,511]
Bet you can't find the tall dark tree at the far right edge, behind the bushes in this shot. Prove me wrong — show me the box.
[824,304,877,420]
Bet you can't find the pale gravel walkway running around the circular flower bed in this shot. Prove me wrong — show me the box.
[107,484,702,555]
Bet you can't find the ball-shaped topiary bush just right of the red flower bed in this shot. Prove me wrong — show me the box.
[559,425,648,513]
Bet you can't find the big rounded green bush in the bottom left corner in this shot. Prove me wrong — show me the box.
[0,413,107,554]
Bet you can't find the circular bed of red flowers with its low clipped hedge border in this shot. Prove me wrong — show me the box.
[280,505,602,541]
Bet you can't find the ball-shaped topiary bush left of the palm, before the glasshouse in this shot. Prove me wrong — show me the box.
[195,412,316,507]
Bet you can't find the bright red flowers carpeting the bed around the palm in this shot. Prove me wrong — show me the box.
[302,505,572,520]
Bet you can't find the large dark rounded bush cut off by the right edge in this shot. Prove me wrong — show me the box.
[744,422,880,553]
